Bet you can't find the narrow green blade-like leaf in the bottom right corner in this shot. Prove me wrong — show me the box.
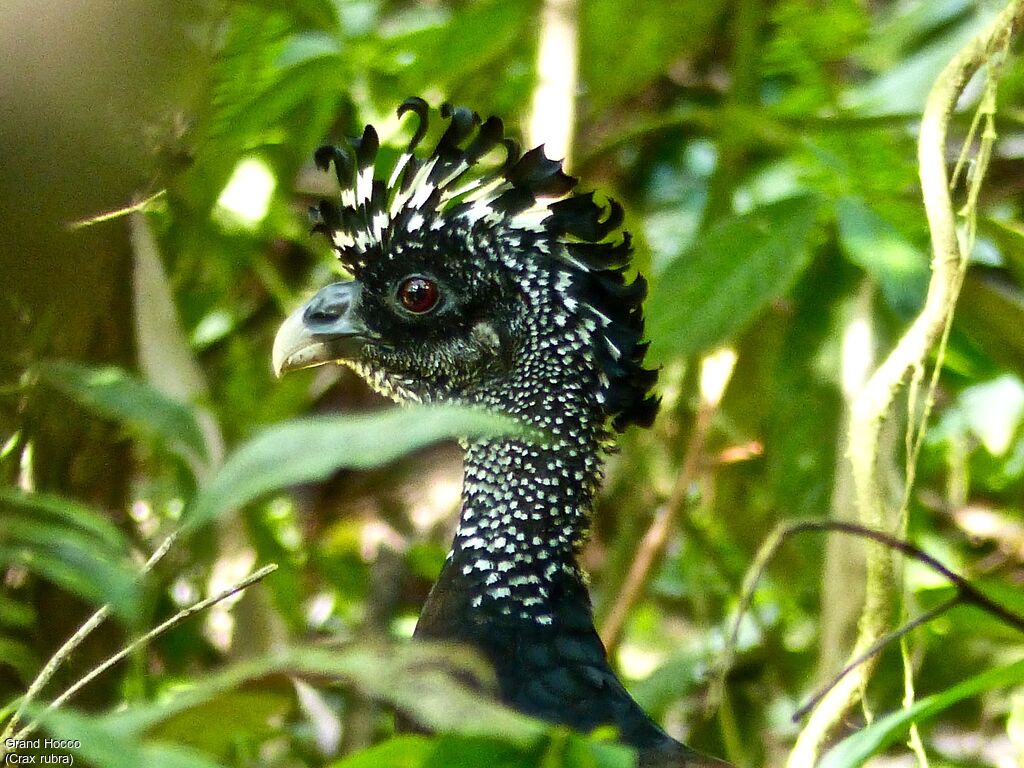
[818,660,1024,768]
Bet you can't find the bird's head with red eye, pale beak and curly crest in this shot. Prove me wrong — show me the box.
[273,98,657,429]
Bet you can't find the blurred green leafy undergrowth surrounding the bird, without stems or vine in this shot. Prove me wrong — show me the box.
[0,0,1024,768]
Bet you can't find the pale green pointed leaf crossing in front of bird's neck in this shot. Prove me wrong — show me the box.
[185,407,522,526]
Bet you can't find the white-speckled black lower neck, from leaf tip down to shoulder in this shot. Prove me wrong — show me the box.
[417,401,601,640]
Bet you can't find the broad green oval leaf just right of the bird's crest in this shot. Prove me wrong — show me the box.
[647,197,818,360]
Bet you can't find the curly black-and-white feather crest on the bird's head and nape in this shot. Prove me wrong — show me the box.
[311,97,657,430]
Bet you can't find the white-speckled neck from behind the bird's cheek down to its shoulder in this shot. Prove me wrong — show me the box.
[417,307,607,640]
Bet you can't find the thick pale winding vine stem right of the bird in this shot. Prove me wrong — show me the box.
[787,0,1024,768]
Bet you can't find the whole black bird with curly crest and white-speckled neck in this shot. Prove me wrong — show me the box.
[273,98,724,766]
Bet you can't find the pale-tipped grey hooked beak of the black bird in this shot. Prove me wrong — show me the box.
[273,281,369,377]
